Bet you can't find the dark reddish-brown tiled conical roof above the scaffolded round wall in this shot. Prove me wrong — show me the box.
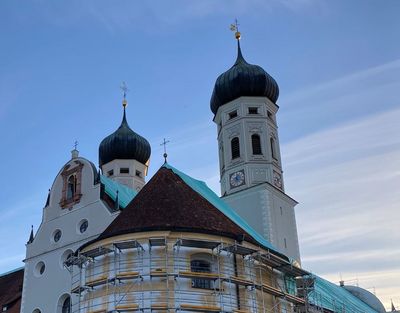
[99,167,256,242]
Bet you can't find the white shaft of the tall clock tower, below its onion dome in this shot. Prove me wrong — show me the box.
[214,97,300,262]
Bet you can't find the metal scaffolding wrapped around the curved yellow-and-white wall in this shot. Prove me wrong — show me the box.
[65,237,309,313]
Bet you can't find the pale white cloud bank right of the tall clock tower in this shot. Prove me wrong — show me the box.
[282,109,400,304]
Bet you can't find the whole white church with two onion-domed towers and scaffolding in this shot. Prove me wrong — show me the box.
[0,32,385,313]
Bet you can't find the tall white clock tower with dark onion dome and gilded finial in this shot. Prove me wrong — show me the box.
[210,28,300,262]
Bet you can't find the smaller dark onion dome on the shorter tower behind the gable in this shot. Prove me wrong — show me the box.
[99,108,151,166]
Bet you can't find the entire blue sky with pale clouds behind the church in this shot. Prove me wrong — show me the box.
[0,0,400,306]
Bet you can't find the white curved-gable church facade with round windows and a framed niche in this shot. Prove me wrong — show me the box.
[21,155,118,313]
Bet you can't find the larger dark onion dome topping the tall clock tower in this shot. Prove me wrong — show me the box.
[210,40,279,114]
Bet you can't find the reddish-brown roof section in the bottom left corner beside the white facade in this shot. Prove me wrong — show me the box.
[0,269,24,313]
